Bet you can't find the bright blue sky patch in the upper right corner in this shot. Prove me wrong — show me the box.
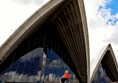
[98,0,118,25]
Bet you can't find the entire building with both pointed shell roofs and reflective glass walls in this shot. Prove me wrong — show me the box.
[0,0,118,83]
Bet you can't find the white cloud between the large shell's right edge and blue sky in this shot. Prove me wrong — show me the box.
[84,0,118,61]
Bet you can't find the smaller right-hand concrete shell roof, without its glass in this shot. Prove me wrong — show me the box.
[90,44,118,82]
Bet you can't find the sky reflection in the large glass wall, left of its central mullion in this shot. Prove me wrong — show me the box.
[0,48,43,82]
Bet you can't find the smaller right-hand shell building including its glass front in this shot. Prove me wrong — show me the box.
[90,44,118,83]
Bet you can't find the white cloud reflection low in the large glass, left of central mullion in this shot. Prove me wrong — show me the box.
[1,71,43,82]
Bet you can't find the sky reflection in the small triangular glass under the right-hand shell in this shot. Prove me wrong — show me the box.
[92,64,111,83]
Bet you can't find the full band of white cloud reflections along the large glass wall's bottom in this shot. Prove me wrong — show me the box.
[0,71,60,82]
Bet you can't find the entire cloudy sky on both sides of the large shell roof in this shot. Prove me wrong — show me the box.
[0,0,118,68]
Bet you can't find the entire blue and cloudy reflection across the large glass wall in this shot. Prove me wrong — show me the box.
[0,48,78,83]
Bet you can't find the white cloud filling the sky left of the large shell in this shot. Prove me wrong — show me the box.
[0,0,48,46]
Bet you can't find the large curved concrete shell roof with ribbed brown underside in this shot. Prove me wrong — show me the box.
[0,0,90,83]
